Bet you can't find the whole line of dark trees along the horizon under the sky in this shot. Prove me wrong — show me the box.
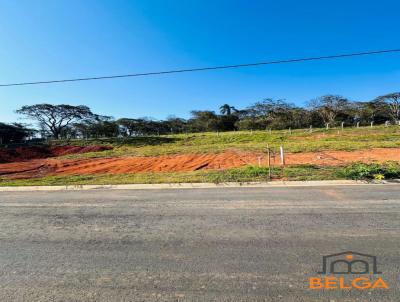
[0,92,400,143]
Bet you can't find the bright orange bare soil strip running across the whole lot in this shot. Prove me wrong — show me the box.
[0,148,400,179]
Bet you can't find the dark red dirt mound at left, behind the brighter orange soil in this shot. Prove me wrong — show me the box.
[0,146,112,163]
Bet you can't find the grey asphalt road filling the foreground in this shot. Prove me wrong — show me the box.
[0,185,400,302]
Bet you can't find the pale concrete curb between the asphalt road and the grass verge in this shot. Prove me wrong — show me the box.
[0,180,400,192]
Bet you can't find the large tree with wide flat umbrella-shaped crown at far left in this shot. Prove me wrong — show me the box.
[16,104,96,139]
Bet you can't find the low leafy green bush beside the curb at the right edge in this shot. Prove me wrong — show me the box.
[342,162,400,180]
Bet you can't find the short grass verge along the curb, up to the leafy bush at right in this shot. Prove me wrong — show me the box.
[0,165,340,186]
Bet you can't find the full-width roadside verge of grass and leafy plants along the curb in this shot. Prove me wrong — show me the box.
[0,162,400,186]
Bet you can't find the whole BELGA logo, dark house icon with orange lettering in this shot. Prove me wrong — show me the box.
[309,251,389,290]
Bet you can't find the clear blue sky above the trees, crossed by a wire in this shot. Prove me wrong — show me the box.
[0,0,400,122]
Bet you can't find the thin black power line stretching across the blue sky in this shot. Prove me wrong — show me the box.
[0,49,400,87]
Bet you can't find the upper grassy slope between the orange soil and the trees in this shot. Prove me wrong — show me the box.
[54,126,400,158]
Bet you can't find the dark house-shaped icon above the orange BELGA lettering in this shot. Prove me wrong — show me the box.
[318,251,382,275]
